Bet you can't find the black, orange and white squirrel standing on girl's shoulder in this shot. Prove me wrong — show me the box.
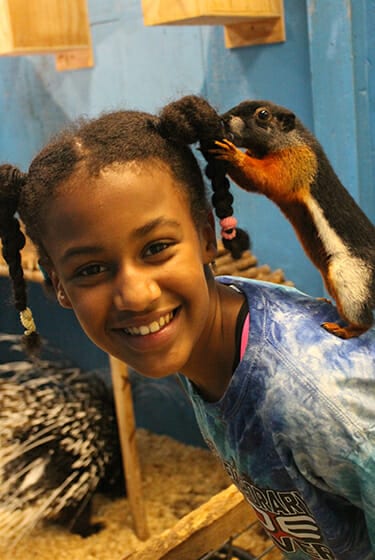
[211,100,375,339]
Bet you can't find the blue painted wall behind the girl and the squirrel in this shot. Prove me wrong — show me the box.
[0,0,375,442]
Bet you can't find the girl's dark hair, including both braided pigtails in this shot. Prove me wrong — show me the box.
[0,95,250,351]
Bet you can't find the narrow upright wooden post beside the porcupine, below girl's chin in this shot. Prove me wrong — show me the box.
[109,356,149,540]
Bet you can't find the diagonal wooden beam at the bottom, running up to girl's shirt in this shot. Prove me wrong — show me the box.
[122,485,257,560]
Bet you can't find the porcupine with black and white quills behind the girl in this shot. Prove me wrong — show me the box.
[0,340,124,548]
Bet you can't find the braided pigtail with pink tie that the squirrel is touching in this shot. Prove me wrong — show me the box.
[157,95,250,259]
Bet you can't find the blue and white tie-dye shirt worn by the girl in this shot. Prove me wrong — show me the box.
[181,277,375,560]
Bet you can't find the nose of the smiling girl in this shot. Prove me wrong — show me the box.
[114,270,161,311]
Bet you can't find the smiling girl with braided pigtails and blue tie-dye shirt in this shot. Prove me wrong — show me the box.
[0,96,375,560]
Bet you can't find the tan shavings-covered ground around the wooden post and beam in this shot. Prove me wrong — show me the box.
[0,429,282,560]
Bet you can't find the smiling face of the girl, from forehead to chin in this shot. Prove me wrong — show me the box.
[43,162,216,378]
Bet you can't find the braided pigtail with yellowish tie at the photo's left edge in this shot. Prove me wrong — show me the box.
[0,165,40,354]
